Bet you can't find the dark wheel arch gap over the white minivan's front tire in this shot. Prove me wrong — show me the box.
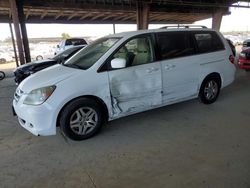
[56,95,109,127]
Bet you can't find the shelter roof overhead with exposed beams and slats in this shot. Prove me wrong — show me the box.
[0,0,237,24]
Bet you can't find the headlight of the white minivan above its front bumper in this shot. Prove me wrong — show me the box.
[23,86,56,105]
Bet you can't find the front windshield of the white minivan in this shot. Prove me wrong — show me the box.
[64,38,119,70]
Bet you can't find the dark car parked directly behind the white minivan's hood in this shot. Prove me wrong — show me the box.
[14,45,84,84]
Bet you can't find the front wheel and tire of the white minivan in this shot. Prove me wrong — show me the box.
[59,98,105,140]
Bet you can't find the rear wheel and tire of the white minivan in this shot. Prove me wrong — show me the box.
[199,76,221,104]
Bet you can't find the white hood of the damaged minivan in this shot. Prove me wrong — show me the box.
[19,65,80,93]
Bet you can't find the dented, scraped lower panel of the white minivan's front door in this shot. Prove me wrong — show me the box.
[108,63,162,117]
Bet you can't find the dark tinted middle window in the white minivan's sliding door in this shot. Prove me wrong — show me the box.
[157,32,195,60]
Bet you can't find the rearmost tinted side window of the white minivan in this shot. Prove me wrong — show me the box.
[194,32,225,53]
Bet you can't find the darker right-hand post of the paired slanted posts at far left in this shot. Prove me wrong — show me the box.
[16,0,31,63]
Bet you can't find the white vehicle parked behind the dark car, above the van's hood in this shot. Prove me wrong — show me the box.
[55,38,87,55]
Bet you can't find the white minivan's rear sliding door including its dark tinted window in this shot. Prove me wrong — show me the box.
[156,31,200,104]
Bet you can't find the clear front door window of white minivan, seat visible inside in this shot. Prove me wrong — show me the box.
[111,36,153,67]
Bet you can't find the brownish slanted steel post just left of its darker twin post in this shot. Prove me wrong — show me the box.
[9,0,25,65]
